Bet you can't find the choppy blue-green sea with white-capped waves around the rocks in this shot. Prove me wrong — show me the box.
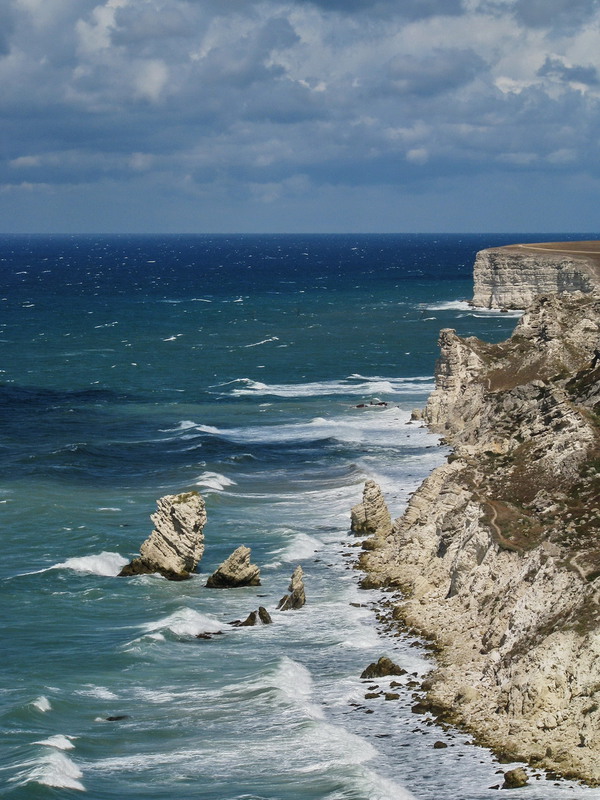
[0,233,600,800]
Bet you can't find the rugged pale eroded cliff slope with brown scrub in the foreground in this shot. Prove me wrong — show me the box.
[360,293,600,784]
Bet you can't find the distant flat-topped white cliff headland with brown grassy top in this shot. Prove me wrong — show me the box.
[473,242,600,309]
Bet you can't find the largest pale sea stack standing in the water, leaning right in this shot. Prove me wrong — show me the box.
[119,492,206,580]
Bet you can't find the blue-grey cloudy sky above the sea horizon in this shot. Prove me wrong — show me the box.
[0,0,600,233]
